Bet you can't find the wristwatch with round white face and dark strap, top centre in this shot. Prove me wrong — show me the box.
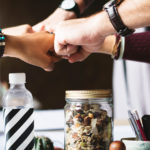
[59,0,80,17]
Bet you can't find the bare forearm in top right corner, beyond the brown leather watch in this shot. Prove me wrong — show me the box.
[118,0,150,29]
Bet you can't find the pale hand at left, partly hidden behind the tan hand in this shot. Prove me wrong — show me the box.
[3,24,34,36]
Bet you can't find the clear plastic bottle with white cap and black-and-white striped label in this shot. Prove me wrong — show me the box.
[3,73,34,150]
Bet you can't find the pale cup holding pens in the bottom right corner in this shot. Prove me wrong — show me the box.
[122,138,150,150]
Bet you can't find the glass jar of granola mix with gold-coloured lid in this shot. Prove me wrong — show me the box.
[65,90,113,150]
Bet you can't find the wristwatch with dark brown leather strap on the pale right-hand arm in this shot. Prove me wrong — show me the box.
[104,0,135,36]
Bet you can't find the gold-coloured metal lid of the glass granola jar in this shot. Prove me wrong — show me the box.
[66,89,112,99]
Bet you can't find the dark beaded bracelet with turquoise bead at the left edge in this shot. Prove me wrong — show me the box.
[0,29,5,57]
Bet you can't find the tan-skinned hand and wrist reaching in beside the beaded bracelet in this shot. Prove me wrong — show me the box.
[4,32,60,71]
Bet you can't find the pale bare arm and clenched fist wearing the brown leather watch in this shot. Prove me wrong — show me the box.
[55,0,150,63]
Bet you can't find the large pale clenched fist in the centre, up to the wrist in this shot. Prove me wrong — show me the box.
[55,16,105,63]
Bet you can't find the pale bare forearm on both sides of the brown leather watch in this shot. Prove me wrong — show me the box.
[93,0,150,36]
